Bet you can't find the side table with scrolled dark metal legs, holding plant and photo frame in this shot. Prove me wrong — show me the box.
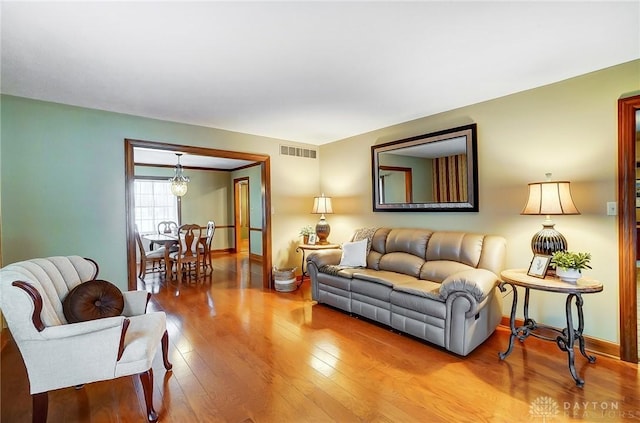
[498,269,603,388]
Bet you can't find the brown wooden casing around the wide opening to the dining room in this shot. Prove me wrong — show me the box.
[124,139,272,290]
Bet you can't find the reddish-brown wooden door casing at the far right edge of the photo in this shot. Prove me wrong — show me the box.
[618,95,640,363]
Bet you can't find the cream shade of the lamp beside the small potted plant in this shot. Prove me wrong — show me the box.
[520,181,580,215]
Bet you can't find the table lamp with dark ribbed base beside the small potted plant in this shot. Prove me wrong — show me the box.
[520,173,580,256]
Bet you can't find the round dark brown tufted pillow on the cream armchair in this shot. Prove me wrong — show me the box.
[62,279,124,323]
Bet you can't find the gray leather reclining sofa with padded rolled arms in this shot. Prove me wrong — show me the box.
[307,228,506,356]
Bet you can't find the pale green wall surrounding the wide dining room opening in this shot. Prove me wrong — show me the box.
[0,95,319,289]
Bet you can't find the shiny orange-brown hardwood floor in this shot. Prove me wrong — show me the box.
[0,255,640,423]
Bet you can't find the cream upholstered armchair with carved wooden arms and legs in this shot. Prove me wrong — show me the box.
[0,256,172,422]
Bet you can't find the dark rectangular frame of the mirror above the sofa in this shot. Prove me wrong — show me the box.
[371,123,478,212]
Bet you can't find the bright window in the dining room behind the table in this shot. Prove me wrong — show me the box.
[133,179,178,234]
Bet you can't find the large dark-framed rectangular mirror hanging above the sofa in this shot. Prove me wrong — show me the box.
[371,123,478,212]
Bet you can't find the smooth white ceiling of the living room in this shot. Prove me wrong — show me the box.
[0,0,640,145]
